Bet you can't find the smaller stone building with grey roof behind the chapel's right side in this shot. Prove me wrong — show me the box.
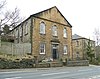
[72,34,95,60]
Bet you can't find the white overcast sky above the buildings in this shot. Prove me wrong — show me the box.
[7,0,100,39]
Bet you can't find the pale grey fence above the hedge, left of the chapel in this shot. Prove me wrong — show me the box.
[0,42,31,55]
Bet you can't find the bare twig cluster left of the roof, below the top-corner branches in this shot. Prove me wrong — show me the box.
[0,8,22,28]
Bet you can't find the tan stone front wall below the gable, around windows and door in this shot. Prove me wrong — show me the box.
[32,18,72,59]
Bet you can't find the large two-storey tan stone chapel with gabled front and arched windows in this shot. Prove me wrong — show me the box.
[10,6,72,60]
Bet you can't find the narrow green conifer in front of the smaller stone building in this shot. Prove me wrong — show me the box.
[86,39,95,62]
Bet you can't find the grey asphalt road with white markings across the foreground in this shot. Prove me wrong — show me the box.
[0,66,100,79]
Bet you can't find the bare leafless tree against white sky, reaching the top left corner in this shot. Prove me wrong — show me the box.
[0,0,22,30]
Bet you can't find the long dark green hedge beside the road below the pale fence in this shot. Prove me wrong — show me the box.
[0,58,34,69]
